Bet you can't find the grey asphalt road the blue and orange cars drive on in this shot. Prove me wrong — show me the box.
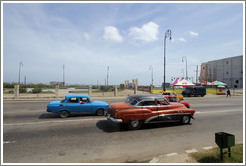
[3,95,243,163]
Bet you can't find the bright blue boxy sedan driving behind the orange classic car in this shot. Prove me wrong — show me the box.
[47,94,109,118]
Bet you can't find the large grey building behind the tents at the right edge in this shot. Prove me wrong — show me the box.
[200,55,243,88]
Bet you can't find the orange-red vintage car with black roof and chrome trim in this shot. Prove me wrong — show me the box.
[107,94,195,130]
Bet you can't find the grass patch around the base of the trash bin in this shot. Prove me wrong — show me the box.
[190,144,243,163]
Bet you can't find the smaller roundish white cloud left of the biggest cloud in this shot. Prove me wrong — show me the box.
[103,26,123,43]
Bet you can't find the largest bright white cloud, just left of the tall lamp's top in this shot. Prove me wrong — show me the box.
[129,22,159,42]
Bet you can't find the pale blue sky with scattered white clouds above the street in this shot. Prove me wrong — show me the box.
[1,2,245,86]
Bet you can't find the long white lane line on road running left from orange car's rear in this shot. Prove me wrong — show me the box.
[3,118,106,126]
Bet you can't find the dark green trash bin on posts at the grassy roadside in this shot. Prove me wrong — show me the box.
[215,132,235,160]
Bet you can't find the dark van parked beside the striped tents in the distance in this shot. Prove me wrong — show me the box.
[182,86,206,97]
